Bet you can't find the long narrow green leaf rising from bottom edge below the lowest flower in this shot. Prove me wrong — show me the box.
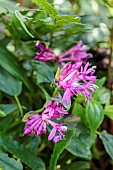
[50,129,74,170]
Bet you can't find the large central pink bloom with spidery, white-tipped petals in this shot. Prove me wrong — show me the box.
[57,62,97,103]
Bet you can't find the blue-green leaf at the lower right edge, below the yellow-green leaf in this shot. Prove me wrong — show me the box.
[100,130,113,159]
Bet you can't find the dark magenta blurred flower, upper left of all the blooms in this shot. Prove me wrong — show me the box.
[35,41,57,62]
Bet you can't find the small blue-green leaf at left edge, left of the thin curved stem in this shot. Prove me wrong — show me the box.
[0,104,18,115]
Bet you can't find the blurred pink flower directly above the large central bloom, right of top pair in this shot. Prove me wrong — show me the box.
[58,41,93,65]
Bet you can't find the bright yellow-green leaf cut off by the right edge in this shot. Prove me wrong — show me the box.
[104,105,113,120]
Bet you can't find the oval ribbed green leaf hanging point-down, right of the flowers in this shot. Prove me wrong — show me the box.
[86,101,104,135]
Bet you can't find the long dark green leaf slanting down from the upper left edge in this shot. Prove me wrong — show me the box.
[0,44,33,92]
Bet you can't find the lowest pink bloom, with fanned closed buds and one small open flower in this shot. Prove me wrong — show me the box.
[24,113,67,142]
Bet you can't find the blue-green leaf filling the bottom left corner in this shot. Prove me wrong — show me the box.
[0,152,23,170]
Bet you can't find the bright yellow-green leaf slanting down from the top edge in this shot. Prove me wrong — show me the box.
[32,0,58,20]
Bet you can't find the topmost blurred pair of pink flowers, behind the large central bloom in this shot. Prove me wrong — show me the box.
[35,41,92,66]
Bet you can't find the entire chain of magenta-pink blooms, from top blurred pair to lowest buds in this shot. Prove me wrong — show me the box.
[24,41,98,142]
